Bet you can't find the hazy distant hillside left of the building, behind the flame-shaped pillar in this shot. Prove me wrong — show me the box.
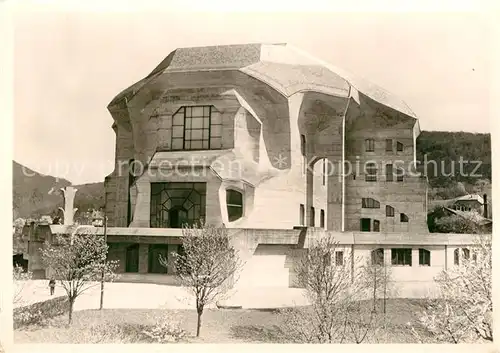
[12,161,104,219]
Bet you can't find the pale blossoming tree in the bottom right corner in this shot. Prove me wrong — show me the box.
[413,236,493,343]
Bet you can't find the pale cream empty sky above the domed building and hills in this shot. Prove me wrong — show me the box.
[13,11,492,184]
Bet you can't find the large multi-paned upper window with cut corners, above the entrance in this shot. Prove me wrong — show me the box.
[171,106,222,150]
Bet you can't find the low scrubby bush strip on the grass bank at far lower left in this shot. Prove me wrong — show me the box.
[13,297,69,329]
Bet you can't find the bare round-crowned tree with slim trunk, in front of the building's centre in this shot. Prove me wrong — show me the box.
[160,224,241,337]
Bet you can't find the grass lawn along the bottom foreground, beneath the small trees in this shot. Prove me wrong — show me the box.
[14,299,432,343]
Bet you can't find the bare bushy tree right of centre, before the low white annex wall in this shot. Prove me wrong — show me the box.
[281,236,377,343]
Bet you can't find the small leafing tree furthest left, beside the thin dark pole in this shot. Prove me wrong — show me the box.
[42,234,118,324]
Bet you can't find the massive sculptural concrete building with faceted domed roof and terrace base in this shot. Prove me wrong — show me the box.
[23,44,484,296]
